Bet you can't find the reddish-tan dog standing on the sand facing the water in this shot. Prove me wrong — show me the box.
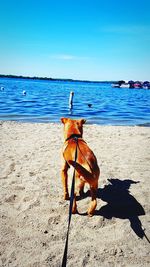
[61,118,100,216]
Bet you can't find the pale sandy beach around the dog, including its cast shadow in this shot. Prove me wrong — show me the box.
[0,122,150,267]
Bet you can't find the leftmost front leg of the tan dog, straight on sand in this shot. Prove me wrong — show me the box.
[61,161,69,200]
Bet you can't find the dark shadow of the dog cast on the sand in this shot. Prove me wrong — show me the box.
[79,179,150,242]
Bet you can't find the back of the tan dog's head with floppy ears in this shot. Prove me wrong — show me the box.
[61,118,86,139]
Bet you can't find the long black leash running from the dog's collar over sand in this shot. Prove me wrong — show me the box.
[61,137,78,267]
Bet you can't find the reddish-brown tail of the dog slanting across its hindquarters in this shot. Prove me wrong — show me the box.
[68,160,94,184]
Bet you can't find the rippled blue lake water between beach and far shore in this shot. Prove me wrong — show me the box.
[0,78,150,126]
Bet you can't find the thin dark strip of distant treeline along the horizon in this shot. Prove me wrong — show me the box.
[0,74,114,83]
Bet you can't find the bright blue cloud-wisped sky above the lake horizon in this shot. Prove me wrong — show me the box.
[0,0,150,81]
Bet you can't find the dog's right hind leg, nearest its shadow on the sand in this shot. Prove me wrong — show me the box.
[87,182,98,216]
